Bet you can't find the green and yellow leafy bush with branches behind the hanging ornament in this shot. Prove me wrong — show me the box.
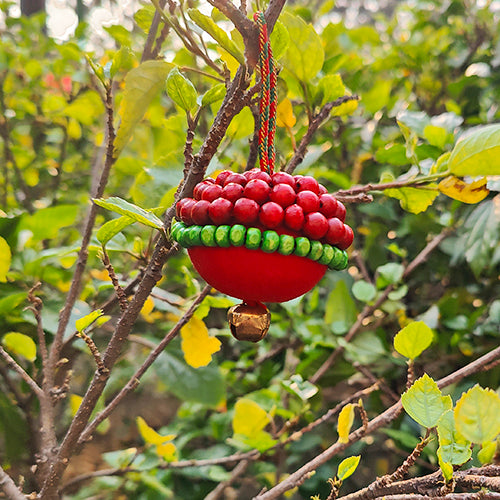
[0,0,500,500]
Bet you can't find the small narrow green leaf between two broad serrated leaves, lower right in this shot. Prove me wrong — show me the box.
[437,410,472,465]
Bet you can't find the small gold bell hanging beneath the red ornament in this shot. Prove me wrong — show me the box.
[227,303,271,342]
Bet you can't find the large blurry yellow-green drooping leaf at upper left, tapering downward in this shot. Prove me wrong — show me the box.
[113,61,173,158]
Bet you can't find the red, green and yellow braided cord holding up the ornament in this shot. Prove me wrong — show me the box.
[254,12,278,174]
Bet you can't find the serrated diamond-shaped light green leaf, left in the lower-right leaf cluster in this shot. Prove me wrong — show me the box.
[401,373,452,428]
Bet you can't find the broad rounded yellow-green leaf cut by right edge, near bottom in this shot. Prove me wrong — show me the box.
[455,385,500,443]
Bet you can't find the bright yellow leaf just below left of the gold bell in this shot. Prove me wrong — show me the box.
[181,316,221,368]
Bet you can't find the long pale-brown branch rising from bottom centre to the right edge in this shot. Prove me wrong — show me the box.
[254,347,500,500]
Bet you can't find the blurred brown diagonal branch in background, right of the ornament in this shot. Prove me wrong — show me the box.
[309,230,450,384]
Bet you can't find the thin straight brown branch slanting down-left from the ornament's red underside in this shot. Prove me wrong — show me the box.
[78,285,211,444]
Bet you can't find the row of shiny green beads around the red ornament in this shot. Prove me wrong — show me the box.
[172,222,347,271]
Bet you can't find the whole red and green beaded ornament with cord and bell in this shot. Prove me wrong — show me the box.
[172,12,353,342]
